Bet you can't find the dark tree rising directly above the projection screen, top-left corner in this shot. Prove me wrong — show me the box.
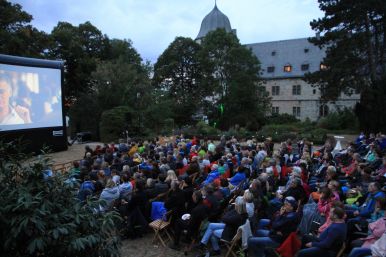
[0,0,48,58]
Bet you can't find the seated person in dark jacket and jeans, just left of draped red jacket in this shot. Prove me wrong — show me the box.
[248,197,299,257]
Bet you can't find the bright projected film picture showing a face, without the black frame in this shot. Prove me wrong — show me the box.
[0,64,63,131]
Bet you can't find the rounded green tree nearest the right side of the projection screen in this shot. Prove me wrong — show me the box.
[70,39,151,138]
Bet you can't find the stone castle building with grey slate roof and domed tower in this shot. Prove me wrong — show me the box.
[196,4,360,121]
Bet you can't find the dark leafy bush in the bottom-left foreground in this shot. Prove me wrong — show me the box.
[0,142,120,257]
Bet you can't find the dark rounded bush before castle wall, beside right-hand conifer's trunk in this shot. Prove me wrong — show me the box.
[317,108,358,130]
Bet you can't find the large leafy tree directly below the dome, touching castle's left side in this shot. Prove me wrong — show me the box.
[200,29,269,129]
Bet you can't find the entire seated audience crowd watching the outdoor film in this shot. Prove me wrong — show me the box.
[70,134,386,257]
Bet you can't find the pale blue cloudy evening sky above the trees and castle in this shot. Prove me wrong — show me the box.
[11,0,322,62]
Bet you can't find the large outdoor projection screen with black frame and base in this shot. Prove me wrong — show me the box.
[0,55,67,150]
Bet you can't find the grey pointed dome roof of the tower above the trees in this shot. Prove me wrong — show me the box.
[196,4,232,39]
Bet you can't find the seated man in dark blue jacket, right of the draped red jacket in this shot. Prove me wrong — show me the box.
[297,207,347,257]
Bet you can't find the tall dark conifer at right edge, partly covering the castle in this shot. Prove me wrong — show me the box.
[306,0,386,131]
